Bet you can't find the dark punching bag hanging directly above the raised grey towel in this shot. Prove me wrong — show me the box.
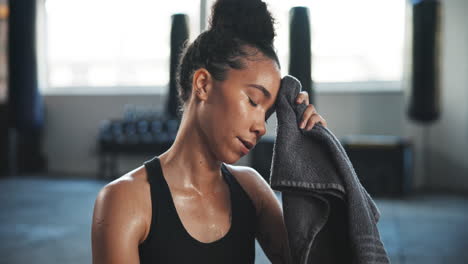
[289,7,314,103]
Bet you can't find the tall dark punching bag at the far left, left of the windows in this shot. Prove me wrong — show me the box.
[8,0,46,173]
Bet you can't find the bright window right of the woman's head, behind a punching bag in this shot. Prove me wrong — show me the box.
[266,0,405,89]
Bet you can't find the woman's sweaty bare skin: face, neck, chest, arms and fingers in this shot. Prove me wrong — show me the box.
[92,54,326,263]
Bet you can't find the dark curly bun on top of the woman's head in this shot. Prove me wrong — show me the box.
[210,0,275,45]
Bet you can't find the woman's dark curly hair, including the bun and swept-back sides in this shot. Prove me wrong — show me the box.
[177,0,280,115]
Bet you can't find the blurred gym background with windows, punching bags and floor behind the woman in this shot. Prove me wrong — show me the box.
[0,0,468,264]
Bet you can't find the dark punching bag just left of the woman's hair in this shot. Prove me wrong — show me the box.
[166,14,189,118]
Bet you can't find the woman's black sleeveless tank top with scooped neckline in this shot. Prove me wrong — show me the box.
[138,156,256,264]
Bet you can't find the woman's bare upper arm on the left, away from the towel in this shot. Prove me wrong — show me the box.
[91,181,145,264]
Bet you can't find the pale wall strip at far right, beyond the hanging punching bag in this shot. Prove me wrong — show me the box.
[427,0,468,191]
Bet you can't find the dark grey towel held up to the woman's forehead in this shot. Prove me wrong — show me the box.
[270,76,390,264]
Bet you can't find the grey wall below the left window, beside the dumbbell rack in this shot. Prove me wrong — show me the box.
[44,95,164,176]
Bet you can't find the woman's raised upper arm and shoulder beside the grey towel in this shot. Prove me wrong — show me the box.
[229,167,291,264]
